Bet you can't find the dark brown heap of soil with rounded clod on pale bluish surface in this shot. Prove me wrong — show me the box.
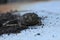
[0,12,42,35]
